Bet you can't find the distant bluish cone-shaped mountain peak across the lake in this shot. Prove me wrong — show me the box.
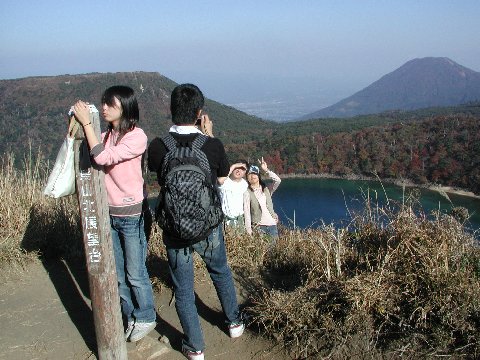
[302,57,480,119]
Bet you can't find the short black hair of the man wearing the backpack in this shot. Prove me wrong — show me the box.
[170,84,205,125]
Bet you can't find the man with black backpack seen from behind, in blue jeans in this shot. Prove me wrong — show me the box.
[148,84,245,360]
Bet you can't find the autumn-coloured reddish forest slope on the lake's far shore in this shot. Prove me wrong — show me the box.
[238,114,480,193]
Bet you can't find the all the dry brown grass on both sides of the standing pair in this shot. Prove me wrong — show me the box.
[0,150,480,359]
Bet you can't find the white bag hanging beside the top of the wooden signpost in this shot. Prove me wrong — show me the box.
[43,136,75,198]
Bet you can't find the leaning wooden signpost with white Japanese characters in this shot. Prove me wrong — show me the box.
[74,106,127,360]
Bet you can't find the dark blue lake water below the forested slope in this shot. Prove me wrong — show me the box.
[273,179,480,230]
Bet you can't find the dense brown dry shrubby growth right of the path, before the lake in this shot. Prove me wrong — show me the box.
[248,198,480,359]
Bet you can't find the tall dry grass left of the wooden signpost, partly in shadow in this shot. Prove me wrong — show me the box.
[0,152,82,278]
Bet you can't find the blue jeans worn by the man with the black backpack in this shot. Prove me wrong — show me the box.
[167,224,241,351]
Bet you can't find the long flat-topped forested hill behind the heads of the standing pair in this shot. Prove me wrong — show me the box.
[0,72,273,159]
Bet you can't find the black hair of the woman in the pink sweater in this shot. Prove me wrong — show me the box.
[102,85,140,142]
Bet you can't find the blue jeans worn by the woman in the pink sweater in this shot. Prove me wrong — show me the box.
[110,215,156,322]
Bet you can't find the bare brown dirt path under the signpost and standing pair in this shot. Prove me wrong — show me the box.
[0,261,289,360]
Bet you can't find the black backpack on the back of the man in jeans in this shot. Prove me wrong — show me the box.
[156,134,223,248]
